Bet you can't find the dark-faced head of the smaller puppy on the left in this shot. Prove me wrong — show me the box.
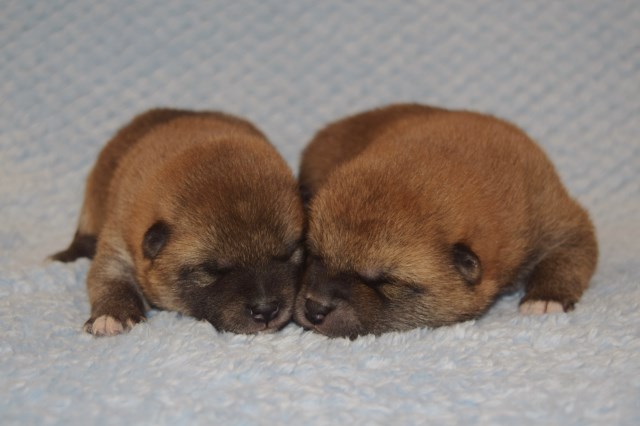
[134,144,304,333]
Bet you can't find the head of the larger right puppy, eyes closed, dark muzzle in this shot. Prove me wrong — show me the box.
[294,163,498,338]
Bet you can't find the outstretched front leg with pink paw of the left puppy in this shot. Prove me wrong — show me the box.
[84,243,145,336]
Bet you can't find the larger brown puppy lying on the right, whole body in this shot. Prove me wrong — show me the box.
[294,105,598,337]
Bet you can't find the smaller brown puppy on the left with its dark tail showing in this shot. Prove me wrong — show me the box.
[52,109,304,335]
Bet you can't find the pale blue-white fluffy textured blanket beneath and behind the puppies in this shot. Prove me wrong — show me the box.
[0,0,640,425]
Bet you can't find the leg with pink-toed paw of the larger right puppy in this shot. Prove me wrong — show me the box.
[520,224,598,315]
